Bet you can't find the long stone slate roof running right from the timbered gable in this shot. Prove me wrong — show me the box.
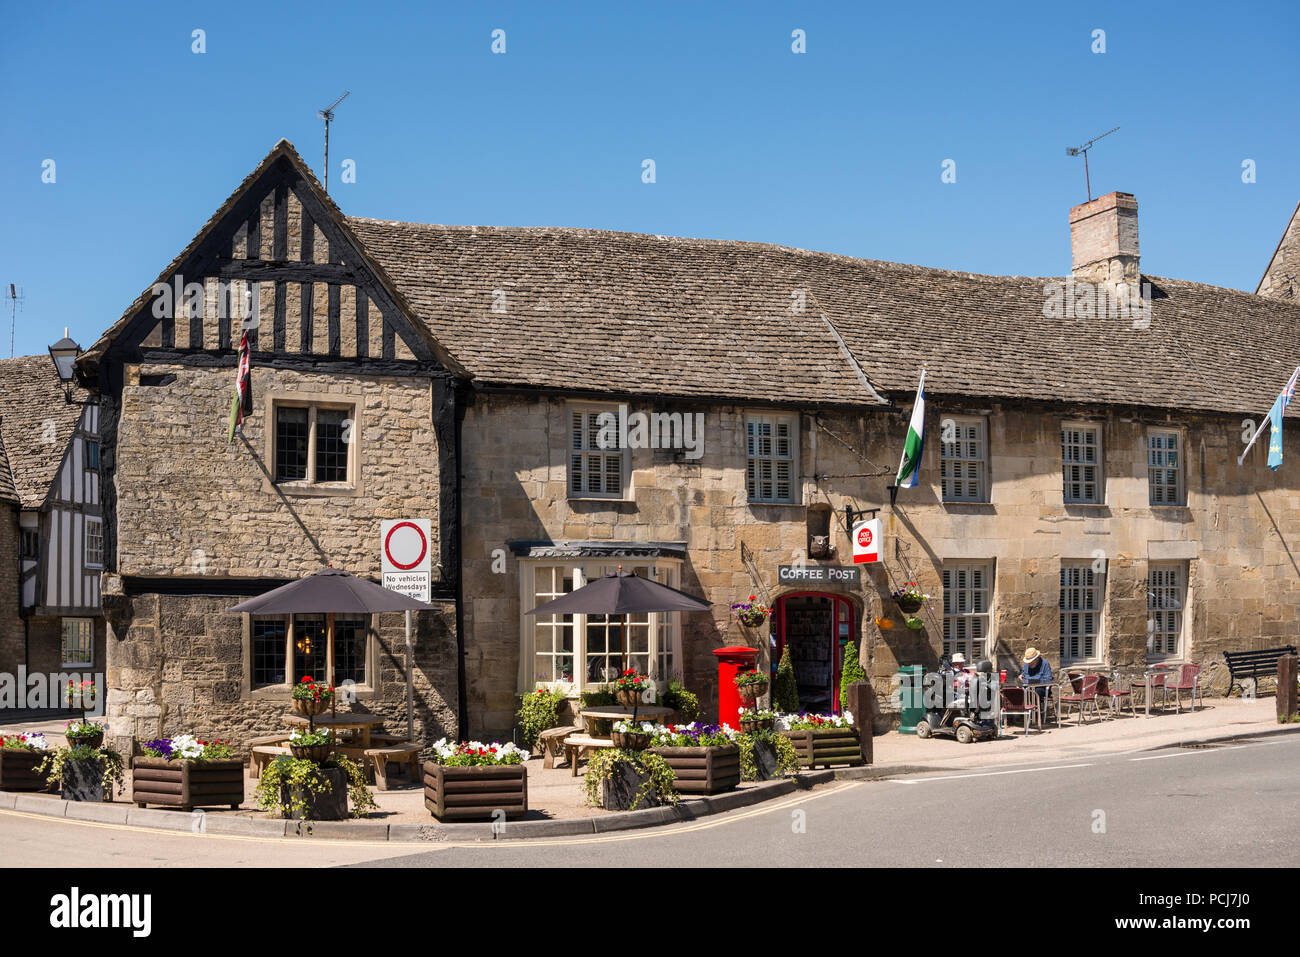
[348,217,1300,413]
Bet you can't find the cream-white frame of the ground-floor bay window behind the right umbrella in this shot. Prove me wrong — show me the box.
[519,558,683,694]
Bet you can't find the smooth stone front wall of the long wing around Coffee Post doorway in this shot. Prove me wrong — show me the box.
[463,395,1300,736]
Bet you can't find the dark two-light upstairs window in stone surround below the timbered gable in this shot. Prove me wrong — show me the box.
[273,402,356,485]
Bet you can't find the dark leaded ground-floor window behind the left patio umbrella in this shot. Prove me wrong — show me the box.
[250,615,371,688]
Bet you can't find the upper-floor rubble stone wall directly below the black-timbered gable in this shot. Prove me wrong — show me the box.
[114,363,439,581]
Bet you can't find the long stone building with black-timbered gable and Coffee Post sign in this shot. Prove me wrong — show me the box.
[78,142,1300,740]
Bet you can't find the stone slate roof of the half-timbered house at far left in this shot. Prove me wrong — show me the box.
[0,355,88,508]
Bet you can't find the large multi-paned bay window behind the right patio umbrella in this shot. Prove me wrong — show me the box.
[520,562,680,690]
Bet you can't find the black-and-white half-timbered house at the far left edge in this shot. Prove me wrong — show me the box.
[0,355,105,675]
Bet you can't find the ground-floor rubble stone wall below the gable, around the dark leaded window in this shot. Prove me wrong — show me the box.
[105,594,456,753]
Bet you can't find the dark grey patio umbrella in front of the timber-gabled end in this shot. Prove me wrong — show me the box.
[226,566,433,731]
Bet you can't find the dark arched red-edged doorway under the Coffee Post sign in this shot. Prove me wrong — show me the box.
[774,592,858,714]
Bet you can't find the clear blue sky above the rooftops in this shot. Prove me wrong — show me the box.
[0,0,1300,355]
